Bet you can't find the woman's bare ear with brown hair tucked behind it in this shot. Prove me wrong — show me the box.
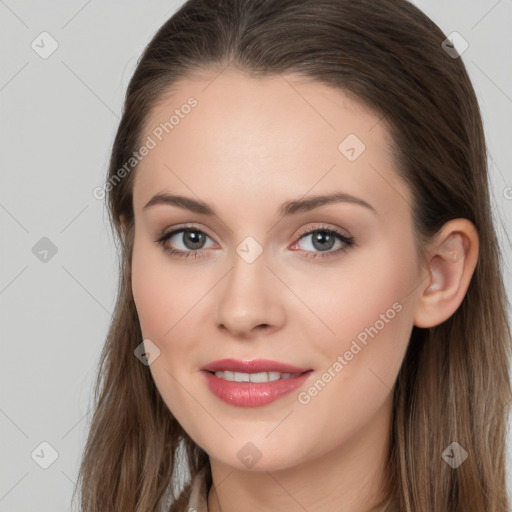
[414,219,479,327]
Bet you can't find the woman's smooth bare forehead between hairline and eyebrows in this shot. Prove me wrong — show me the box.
[133,69,409,218]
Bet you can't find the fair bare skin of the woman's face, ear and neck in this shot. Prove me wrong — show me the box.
[128,68,478,512]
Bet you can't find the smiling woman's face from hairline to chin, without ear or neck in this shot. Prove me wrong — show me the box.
[132,69,429,470]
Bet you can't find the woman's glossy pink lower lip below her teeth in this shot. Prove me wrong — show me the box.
[203,370,312,407]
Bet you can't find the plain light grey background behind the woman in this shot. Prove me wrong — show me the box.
[0,0,512,512]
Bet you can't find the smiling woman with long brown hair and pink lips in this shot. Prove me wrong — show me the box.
[74,0,510,512]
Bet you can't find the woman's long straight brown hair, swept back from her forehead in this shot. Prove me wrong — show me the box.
[75,0,511,512]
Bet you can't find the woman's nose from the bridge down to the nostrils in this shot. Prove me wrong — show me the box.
[213,237,283,334]
